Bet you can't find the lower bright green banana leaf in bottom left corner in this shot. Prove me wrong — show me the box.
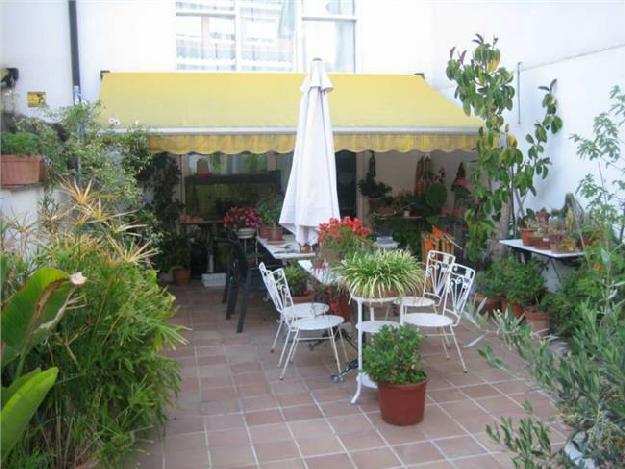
[0,367,59,461]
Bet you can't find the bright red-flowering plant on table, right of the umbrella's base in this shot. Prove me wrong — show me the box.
[318,217,373,267]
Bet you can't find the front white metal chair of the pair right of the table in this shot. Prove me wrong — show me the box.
[400,264,475,373]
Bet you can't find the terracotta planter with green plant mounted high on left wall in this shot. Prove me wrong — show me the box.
[0,132,46,186]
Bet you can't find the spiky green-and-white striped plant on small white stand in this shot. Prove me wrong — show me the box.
[336,249,424,298]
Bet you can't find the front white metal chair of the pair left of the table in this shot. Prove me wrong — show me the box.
[274,269,348,379]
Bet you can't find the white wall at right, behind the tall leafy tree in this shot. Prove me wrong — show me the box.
[431,1,625,208]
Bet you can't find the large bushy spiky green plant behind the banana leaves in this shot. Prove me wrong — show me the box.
[3,185,184,468]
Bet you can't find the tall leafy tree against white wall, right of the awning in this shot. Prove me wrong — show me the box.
[447,34,562,261]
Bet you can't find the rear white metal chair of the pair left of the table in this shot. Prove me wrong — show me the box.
[258,262,329,366]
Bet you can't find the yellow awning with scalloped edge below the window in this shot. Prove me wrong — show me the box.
[100,73,480,154]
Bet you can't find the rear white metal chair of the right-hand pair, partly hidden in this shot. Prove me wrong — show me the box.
[395,250,456,311]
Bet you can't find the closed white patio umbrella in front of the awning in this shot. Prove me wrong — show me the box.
[280,59,341,244]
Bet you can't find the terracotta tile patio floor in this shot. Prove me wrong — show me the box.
[133,285,563,469]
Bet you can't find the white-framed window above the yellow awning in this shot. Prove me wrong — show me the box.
[176,0,357,72]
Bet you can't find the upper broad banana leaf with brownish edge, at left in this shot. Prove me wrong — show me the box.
[0,267,86,376]
